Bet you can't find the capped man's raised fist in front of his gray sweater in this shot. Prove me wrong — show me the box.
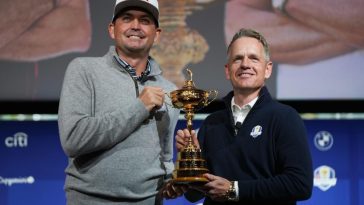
[139,86,164,111]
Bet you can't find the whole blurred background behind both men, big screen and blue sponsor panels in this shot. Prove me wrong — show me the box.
[0,0,364,205]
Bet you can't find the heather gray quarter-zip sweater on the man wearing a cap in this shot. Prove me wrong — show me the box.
[58,46,179,205]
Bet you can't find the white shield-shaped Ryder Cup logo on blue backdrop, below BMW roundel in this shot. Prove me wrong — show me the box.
[313,165,337,191]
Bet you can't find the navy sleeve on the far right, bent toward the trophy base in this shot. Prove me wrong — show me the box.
[238,108,313,202]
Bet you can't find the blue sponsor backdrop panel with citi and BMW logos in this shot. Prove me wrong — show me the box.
[0,117,364,205]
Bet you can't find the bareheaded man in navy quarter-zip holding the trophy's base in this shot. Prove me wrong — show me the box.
[176,29,313,205]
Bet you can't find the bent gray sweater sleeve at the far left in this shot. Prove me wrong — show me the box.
[58,59,149,157]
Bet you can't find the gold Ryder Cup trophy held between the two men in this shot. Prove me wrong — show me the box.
[169,69,217,184]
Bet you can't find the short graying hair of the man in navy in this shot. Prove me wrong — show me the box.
[227,28,270,61]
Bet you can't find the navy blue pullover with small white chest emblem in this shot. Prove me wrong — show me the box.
[186,87,313,205]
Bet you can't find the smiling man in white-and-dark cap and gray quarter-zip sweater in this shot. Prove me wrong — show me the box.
[58,0,182,205]
